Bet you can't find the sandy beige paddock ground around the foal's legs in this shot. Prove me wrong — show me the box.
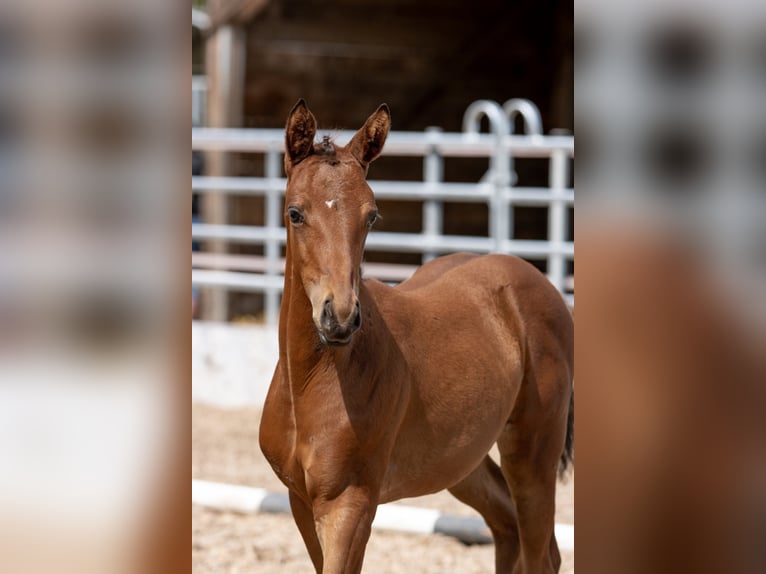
[192,404,574,574]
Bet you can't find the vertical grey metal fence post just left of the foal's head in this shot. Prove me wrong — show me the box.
[264,145,282,326]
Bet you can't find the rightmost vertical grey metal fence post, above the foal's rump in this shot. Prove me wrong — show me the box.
[548,137,569,293]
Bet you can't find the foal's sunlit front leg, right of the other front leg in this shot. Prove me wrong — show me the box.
[314,486,377,574]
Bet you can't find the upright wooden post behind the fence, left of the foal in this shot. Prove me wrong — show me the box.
[201,25,246,321]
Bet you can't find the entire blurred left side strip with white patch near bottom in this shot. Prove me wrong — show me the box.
[0,0,190,574]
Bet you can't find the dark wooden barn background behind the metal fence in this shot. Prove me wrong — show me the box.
[192,0,573,321]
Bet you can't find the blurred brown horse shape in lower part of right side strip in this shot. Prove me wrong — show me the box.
[575,225,766,574]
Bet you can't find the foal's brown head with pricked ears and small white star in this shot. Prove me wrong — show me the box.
[285,99,391,345]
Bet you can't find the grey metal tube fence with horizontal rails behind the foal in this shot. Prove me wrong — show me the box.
[192,99,574,324]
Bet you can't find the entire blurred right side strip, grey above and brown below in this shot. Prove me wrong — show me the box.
[575,0,766,573]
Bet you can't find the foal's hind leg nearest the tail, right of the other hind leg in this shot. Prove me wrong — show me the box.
[497,368,571,574]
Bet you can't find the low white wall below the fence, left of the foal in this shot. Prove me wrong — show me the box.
[192,321,279,407]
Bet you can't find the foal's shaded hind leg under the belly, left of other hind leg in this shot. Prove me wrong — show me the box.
[448,455,519,573]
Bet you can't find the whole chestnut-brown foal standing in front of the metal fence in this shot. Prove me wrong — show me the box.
[260,100,574,573]
